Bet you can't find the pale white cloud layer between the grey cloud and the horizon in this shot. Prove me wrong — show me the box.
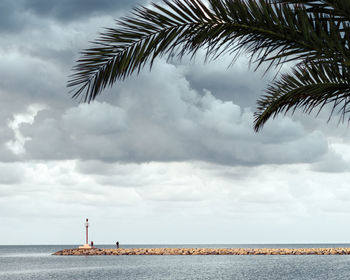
[0,161,350,244]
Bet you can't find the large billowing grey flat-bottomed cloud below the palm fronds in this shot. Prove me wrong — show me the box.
[14,62,330,165]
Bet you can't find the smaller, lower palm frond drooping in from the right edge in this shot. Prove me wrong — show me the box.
[254,62,350,131]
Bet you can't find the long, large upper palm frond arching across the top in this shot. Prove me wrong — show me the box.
[68,0,350,102]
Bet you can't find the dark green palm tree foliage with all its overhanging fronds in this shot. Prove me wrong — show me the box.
[68,0,350,131]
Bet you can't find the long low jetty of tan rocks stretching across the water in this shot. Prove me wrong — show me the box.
[53,248,350,256]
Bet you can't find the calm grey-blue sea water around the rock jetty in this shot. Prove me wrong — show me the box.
[0,244,350,280]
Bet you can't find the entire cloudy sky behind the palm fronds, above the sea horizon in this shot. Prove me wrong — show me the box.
[0,0,350,246]
